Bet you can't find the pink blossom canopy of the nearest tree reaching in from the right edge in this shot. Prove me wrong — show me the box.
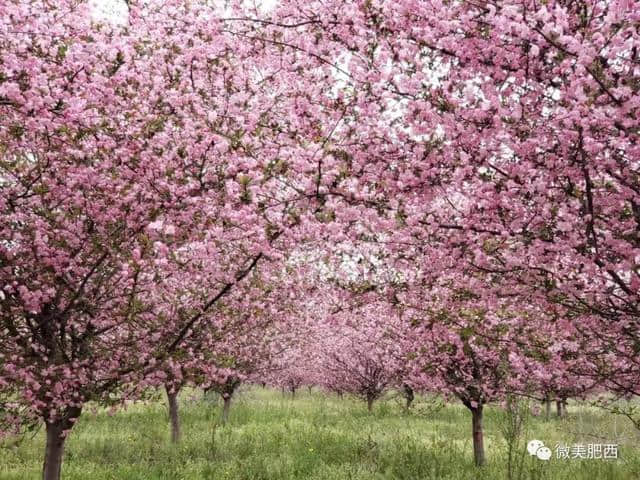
[270,0,640,438]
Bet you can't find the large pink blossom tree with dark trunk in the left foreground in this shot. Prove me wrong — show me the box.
[0,1,340,480]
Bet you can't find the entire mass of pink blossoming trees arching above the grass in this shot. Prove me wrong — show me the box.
[0,0,640,480]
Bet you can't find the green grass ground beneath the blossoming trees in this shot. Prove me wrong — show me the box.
[0,388,640,480]
